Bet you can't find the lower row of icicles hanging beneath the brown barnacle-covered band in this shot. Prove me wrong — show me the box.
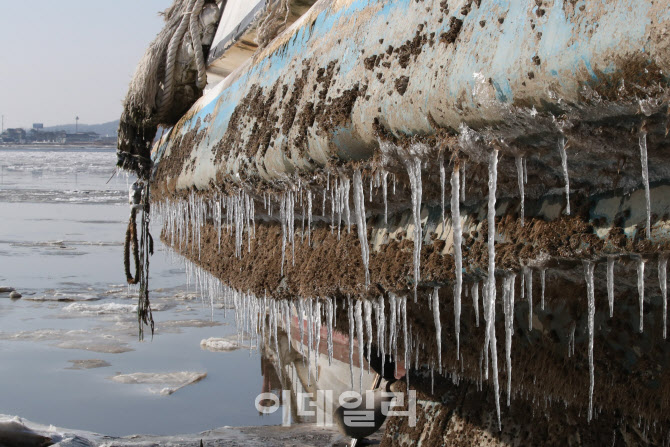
[173,245,668,434]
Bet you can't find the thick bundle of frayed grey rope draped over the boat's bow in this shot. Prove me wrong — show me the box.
[117,0,220,178]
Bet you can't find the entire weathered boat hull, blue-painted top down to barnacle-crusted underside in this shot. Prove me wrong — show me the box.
[152,0,670,445]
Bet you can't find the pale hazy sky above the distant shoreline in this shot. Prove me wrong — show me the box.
[0,0,172,128]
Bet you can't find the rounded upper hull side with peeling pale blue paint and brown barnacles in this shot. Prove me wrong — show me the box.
[152,0,670,200]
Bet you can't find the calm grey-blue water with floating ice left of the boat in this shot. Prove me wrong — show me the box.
[0,148,281,436]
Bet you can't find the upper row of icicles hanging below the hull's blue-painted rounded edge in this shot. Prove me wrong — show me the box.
[154,132,656,430]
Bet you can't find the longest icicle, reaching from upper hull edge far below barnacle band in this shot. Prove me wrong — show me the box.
[486,149,500,429]
